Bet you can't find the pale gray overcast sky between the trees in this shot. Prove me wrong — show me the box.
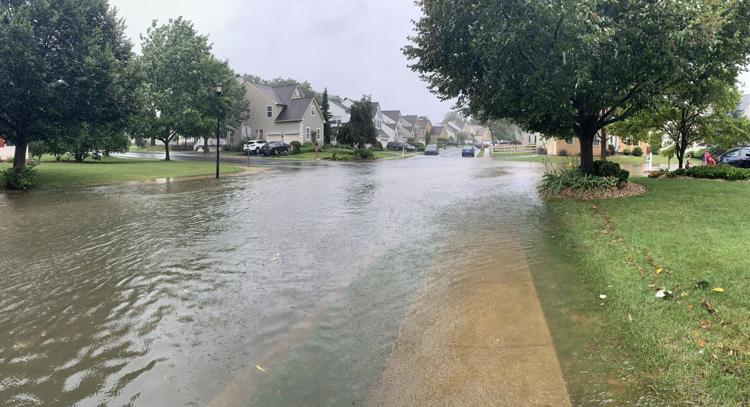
[110,0,452,121]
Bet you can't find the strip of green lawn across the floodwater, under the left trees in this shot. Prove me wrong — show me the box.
[0,158,244,189]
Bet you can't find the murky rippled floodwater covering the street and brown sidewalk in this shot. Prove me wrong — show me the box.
[0,151,567,406]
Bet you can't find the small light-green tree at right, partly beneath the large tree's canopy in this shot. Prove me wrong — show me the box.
[615,79,748,168]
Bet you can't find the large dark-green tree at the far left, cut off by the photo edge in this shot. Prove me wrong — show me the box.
[0,0,134,176]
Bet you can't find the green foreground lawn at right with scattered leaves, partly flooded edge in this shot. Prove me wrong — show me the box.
[534,178,750,406]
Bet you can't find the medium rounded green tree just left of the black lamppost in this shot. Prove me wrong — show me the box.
[136,17,216,161]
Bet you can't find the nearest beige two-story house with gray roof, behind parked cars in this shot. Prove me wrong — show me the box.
[242,83,325,144]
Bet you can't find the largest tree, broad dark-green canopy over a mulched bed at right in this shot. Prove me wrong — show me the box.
[404,0,750,173]
